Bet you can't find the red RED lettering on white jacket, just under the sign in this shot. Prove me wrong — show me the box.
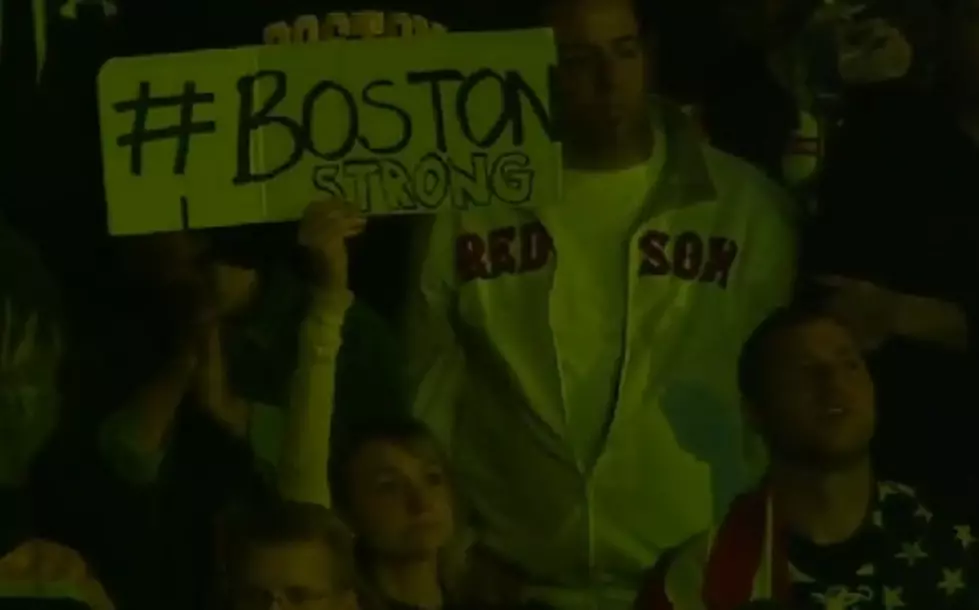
[456,222,554,283]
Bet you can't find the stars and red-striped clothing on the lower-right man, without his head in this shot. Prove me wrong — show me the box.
[635,482,979,610]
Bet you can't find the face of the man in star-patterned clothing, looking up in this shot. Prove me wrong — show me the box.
[758,319,875,468]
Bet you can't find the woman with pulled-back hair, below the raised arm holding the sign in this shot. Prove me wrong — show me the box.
[329,419,474,610]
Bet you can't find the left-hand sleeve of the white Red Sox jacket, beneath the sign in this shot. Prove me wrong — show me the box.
[402,215,465,455]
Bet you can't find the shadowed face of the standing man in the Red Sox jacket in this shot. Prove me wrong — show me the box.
[551,0,648,154]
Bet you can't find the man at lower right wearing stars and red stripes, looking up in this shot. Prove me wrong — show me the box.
[637,309,979,610]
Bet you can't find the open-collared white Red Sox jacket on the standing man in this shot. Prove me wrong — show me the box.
[407,102,796,610]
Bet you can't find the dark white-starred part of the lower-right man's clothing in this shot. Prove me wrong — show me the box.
[788,482,979,610]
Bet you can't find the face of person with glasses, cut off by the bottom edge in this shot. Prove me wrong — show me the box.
[234,541,358,610]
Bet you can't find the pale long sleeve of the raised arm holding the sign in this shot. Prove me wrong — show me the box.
[277,292,352,508]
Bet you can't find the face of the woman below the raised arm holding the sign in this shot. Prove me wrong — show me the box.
[349,440,454,559]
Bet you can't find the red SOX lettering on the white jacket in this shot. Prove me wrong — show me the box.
[639,231,738,288]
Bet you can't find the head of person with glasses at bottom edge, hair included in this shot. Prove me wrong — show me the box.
[225,502,358,610]
